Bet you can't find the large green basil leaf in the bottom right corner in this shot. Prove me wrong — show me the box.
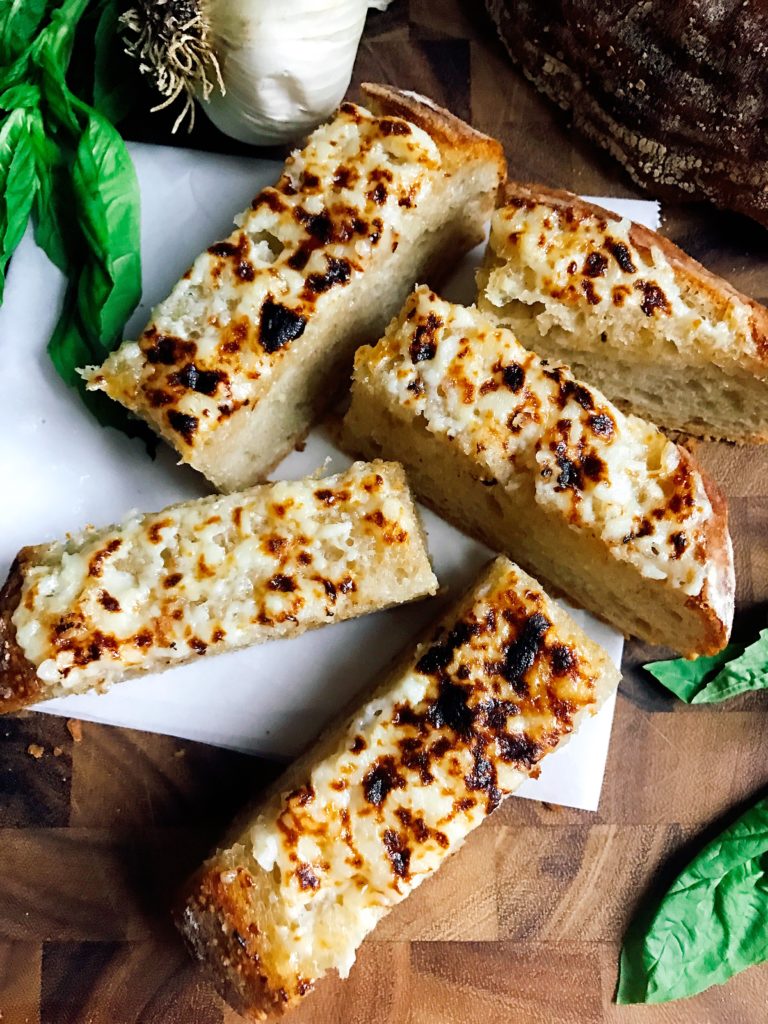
[615,800,768,1004]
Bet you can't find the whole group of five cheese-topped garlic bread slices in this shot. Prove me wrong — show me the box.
[0,86,768,1019]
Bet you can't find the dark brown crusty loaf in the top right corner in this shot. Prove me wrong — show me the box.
[486,0,768,224]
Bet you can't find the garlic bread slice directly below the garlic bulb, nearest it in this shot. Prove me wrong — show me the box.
[84,85,505,490]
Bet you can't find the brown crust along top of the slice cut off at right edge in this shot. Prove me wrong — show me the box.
[502,181,768,380]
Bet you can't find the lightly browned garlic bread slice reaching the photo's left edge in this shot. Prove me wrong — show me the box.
[0,462,437,714]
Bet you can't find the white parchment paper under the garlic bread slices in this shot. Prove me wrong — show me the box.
[0,144,658,810]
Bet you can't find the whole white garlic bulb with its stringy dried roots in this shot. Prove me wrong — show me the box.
[122,0,391,144]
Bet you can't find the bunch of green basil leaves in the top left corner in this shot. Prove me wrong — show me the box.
[0,0,147,437]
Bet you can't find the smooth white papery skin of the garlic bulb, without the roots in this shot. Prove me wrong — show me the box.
[198,0,389,144]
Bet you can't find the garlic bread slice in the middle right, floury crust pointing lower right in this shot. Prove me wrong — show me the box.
[344,288,734,656]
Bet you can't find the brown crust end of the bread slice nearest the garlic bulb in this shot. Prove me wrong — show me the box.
[360,82,507,182]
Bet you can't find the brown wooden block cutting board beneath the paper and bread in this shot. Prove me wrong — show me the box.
[0,0,768,1024]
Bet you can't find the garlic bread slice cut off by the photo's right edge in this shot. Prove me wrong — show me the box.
[478,183,768,442]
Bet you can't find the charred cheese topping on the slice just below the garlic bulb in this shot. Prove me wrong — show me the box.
[86,103,442,451]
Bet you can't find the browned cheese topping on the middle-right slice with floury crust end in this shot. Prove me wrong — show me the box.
[355,288,712,595]
